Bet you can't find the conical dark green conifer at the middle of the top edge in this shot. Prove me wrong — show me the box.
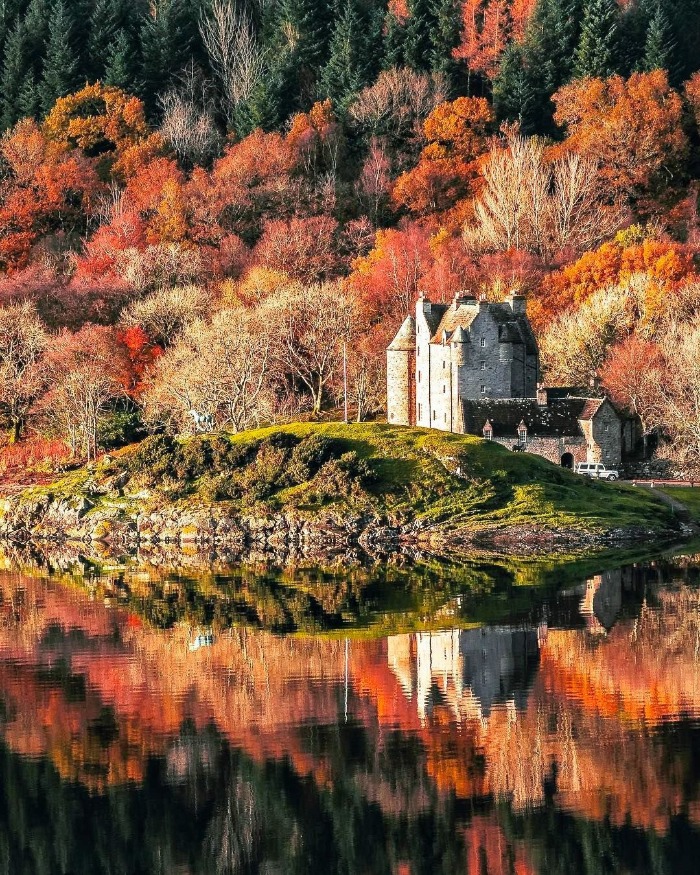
[319,0,369,109]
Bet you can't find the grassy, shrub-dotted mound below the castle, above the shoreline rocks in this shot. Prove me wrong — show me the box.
[20,423,672,532]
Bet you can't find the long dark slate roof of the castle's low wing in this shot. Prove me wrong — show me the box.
[461,398,604,438]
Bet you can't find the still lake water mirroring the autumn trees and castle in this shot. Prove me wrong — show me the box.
[0,555,700,875]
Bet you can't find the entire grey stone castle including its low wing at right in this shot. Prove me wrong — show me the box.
[387,293,636,467]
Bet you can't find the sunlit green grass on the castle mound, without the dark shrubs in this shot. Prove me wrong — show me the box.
[10,423,680,532]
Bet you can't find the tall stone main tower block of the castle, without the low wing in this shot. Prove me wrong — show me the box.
[387,293,539,432]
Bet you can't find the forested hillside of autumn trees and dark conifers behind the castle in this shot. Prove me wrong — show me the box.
[0,0,700,477]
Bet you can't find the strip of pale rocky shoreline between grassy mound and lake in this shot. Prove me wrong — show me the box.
[0,486,696,554]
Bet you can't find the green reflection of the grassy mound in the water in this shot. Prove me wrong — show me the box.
[27,550,660,638]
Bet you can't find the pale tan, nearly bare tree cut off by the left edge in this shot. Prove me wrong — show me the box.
[0,302,49,443]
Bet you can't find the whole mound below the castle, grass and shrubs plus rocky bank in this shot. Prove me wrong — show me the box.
[0,423,677,543]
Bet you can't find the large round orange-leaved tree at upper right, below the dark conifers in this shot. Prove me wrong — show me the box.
[552,70,688,198]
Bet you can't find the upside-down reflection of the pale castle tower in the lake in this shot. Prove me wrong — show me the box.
[387,627,546,721]
